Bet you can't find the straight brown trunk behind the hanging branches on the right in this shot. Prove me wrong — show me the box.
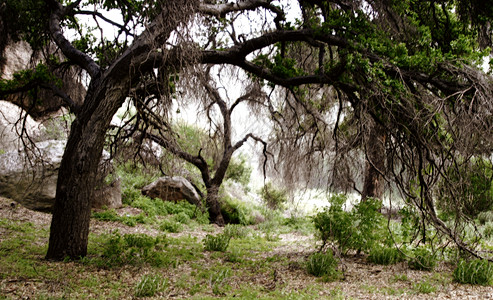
[361,124,386,201]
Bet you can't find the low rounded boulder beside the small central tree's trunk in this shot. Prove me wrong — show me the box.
[142,176,202,207]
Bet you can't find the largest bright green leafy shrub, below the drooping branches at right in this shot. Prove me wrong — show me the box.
[313,194,388,253]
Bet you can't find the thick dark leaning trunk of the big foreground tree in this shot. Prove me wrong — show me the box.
[46,82,124,260]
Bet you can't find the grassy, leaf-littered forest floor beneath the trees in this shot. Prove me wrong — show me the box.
[0,197,493,299]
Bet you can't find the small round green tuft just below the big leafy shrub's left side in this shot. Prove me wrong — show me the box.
[306,250,340,281]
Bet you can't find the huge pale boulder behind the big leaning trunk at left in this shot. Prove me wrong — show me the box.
[0,140,122,212]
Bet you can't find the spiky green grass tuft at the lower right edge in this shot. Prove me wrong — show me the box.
[453,259,493,285]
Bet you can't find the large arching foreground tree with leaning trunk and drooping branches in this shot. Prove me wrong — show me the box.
[0,0,493,259]
